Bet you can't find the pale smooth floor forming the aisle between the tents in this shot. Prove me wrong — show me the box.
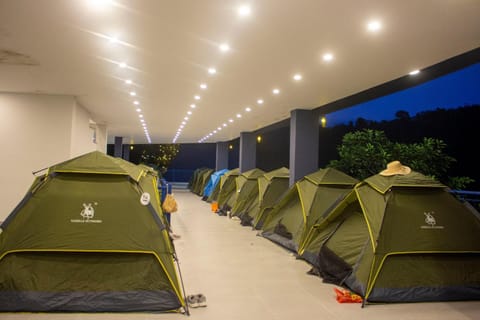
[0,190,480,320]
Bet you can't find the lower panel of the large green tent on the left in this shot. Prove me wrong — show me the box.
[0,252,181,312]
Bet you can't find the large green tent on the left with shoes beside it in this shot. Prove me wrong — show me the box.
[0,151,188,312]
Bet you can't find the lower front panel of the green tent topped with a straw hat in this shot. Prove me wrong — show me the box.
[366,252,480,302]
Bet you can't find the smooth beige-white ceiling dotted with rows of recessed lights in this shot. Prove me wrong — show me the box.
[0,0,480,143]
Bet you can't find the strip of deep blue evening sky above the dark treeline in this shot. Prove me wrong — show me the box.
[326,63,480,126]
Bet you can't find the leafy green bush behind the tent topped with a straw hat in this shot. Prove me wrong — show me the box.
[328,129,474,189]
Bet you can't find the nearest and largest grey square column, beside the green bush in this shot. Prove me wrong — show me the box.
[289,109,319,186]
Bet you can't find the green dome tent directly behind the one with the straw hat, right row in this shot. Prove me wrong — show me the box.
[261,168,358,252]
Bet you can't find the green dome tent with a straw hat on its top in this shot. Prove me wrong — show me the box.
[299,171,480,303]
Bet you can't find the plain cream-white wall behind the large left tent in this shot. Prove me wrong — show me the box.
[0,93,106,221]
